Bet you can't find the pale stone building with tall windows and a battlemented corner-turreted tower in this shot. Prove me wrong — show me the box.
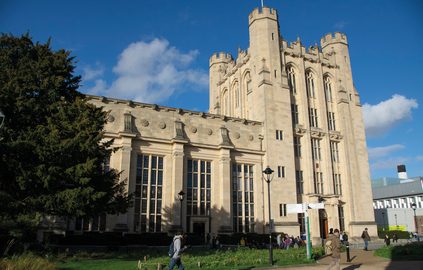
[75,7,377,241]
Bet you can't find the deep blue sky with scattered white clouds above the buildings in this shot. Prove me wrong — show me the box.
[0,0,423,178]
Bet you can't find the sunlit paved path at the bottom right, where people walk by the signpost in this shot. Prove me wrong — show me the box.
[268,249,423,270]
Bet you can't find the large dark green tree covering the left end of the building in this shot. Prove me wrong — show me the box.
[0,34,129,242]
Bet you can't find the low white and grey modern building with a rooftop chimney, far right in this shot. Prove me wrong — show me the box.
[372,165,423,235]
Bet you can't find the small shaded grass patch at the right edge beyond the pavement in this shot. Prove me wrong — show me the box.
[375,242,423,260]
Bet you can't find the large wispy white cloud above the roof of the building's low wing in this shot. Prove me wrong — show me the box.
[90,39,209,103]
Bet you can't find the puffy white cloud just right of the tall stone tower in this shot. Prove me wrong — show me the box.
[363,95,418,136]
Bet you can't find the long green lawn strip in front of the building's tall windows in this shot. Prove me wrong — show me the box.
[56,248,322,270]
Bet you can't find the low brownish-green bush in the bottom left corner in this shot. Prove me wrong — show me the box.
[0,254,56,270]
